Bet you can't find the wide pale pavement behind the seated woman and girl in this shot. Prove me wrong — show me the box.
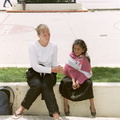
[0,11,120,67]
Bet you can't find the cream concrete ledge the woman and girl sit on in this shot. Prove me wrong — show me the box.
[0,83,120,117]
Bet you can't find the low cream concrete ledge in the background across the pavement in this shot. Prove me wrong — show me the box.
[7,3,87,12]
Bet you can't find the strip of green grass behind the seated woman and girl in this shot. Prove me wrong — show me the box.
[0,67,120,82]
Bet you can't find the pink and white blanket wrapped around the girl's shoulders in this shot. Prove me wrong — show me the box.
[63,52,92,84]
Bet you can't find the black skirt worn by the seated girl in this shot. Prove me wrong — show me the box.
[59,76,94,101]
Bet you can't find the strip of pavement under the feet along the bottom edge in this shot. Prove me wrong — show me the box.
[0,116,120,120]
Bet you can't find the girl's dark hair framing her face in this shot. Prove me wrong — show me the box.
[72,39,87,54]
